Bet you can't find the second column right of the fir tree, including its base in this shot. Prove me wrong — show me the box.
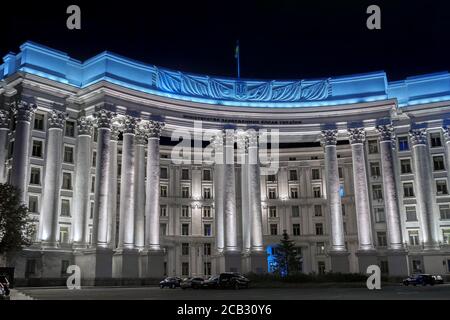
[348,128,377,274]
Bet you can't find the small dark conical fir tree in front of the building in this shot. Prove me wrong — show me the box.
[274,230,300,276]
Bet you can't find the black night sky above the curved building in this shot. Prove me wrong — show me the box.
[0,0,450,80]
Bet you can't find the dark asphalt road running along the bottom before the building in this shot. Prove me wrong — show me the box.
[17,284,450,300]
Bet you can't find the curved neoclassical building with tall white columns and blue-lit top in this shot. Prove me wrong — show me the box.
[0,42,450,283]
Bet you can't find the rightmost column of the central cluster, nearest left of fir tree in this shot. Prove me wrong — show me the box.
[247,130,267,273]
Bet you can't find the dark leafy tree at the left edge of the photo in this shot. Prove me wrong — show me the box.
[0,183,34,262]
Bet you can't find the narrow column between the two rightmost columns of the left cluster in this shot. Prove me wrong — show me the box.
[134,130,147,250]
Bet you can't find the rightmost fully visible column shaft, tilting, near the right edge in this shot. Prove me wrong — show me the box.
[409,129,439,250]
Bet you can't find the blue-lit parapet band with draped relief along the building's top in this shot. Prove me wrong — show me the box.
[0,42,450,108]
